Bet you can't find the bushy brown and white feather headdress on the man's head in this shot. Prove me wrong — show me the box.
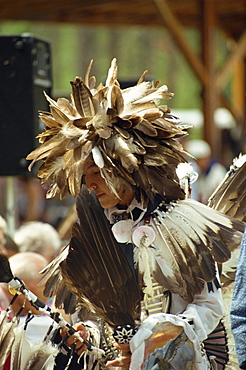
[27,59,188,204]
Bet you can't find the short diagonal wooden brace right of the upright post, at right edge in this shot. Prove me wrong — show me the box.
[216,31,246,89]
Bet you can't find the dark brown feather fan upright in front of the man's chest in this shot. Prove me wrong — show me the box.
[61,186,141,326]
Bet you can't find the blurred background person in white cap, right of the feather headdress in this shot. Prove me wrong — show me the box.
[185,140,227,204]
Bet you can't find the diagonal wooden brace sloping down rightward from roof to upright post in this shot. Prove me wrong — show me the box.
[153,0,209,86]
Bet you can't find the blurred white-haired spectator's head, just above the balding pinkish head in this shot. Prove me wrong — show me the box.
[14,221,61,262]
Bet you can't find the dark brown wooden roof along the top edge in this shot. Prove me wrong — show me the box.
[0,0,246,40]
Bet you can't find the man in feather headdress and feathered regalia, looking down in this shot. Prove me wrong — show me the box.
[24,59,244,370]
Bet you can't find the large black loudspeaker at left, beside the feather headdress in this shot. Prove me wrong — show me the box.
[0,34,52,176]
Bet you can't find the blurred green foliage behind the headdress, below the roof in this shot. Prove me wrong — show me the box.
[0,21,228,109]
